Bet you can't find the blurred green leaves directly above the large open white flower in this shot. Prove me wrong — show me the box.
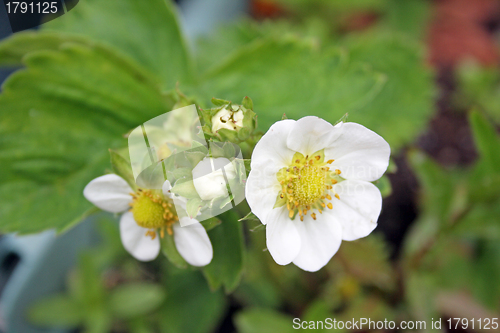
[194,22,435,150]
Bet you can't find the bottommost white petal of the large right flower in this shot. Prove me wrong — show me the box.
[293,213,342,272]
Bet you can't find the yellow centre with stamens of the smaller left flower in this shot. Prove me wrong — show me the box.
[130,189,179,239]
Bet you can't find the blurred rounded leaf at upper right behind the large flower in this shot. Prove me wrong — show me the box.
[344,33,435,151]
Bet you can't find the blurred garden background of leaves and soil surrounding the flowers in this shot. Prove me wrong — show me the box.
[0,0,500,333]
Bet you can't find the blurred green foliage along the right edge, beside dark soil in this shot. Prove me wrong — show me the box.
[404,111,500,319]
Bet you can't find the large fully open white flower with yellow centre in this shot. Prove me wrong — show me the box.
[245,116,390,271]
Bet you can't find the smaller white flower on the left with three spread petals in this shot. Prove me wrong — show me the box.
[83,174,213,266]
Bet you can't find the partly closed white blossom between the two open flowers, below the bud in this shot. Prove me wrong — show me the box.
[192,157,236,200]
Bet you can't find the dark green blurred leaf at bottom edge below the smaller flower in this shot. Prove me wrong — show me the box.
[159,270,226,333]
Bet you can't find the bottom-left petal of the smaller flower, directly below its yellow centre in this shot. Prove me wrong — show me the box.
[120,212,160,261]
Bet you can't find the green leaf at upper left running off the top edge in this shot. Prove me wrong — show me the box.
[42,0,193,89]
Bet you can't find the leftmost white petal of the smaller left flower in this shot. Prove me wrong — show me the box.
[83,174,133,213]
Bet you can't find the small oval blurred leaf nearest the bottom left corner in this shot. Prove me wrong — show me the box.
[28,295,84,328]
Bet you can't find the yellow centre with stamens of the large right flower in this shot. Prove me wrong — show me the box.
[274,149,341,221]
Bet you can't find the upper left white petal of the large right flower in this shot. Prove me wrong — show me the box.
[251,119,295,172]
